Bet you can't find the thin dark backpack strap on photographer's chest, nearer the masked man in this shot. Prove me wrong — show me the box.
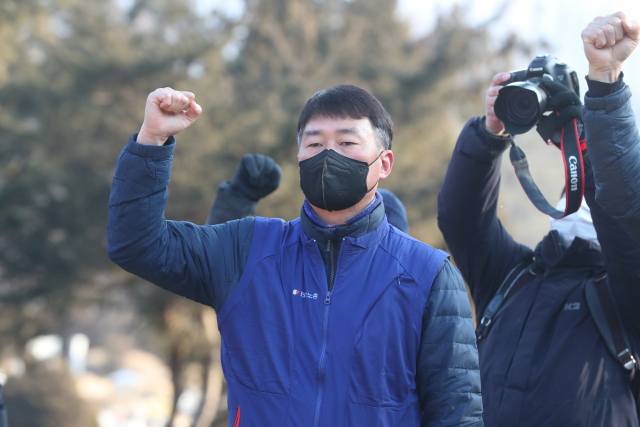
[476,258,539,341]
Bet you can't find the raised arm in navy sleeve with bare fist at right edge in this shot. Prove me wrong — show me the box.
[582,12,640,243]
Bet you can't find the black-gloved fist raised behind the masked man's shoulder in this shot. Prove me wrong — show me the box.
[231,154,282,202]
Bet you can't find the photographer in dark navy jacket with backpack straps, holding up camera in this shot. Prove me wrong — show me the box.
[438,12,640,427]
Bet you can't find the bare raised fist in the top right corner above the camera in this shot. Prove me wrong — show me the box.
[582,12,640,83]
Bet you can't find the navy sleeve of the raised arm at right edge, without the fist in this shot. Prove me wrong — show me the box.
[582,85,640,243]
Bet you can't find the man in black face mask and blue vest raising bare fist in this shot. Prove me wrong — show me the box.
[108,86,482,427]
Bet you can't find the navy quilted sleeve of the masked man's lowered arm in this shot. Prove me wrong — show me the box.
[416,260,483,427]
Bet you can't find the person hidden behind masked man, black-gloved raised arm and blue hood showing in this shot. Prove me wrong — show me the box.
[207,154,409,233]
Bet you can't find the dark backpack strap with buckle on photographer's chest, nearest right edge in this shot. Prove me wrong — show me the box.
[584,274,638,380]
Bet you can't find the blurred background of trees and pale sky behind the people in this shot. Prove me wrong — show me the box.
[0,0,640,427]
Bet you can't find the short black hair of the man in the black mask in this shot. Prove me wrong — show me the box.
[298,85,393,150]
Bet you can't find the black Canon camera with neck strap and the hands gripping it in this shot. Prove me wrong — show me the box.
[485,55,584,219]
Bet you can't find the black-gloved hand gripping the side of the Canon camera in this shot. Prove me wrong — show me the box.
[536,79,583,148]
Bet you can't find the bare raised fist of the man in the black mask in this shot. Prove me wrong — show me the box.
[137,87,202,145]
